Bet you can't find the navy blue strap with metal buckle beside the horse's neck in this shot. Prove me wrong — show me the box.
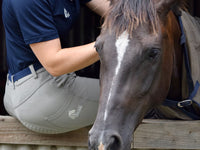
[163,11,200,120]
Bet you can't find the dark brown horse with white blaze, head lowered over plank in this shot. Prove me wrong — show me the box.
[89,0,195,150]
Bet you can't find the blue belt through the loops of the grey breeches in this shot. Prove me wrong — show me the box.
[8,63,42,82]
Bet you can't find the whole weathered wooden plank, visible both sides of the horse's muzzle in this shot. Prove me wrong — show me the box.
[0,116,200,150]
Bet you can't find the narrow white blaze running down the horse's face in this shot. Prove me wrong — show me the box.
[104,31,129,121]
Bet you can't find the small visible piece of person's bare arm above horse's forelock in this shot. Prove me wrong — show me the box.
[86,0,110,17]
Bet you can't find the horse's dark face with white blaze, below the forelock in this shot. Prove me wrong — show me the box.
[89,0,177,150]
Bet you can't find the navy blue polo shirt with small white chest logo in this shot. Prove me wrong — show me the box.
[2,0,90,75]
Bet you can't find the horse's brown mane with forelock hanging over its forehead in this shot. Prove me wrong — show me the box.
[102,0,187,35]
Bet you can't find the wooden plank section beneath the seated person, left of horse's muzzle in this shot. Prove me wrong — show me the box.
[0,116,90,147]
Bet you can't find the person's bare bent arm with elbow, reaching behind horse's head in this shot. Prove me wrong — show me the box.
[30,38,99,76]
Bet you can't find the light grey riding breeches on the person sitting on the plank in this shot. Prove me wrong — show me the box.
[5,69,99,133]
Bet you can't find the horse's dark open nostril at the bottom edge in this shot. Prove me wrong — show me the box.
[108,135,122,150]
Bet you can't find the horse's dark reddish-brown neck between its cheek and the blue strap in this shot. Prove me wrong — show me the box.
[167,12,183,101]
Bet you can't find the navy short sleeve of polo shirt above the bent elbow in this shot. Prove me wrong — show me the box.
[13,0,59,44]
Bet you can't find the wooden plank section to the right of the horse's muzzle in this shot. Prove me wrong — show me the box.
[134,120,200,149]
